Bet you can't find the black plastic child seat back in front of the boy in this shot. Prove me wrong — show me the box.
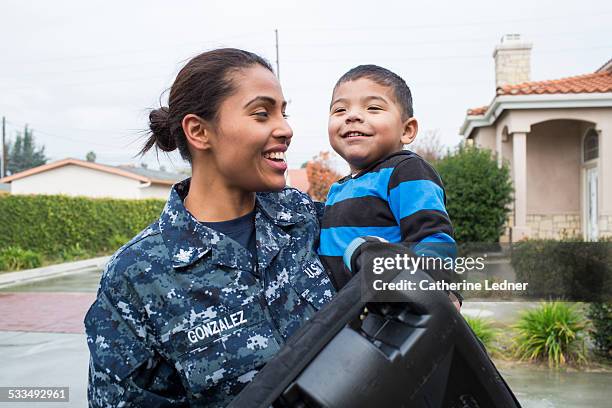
[229,243,520,408]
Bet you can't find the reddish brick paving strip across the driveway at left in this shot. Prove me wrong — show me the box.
[0,292,96,333]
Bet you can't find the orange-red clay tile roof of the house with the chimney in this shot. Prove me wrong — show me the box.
[467,70,612,115]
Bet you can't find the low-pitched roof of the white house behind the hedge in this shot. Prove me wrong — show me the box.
[0,158,184,186]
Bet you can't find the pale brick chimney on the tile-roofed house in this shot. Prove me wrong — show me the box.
[493,34,532,88]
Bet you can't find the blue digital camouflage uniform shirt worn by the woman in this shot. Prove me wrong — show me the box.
[85,179,334,407]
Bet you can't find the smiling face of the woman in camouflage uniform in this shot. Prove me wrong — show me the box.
[211,65,293,191]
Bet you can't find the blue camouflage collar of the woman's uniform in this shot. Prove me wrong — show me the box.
[159,178,304,269]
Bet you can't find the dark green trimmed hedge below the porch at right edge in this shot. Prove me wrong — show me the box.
[511,238,612,302]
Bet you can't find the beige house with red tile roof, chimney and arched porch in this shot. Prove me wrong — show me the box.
[460,35,612,241]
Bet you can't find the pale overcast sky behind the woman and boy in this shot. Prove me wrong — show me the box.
[0,0,612,170]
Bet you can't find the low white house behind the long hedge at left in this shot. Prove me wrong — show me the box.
[0,159,188,200]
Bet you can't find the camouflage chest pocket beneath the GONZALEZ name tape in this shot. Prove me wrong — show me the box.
[169,303,280,396]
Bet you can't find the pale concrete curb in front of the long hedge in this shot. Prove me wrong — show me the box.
[0,256,110,289]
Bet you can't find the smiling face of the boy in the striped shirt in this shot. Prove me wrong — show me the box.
[328,78,417,172]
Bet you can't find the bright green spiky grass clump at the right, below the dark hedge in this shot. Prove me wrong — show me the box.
[514,302,586,367]
